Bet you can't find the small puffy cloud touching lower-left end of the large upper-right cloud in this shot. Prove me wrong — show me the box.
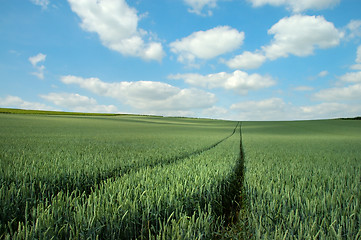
[226,51,266,69]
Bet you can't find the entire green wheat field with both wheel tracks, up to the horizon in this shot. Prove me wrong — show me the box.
[0,109,361,239]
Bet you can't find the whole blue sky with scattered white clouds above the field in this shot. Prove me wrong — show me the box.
[0,0,361,120]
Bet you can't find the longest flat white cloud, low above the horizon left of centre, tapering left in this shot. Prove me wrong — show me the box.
[61,76,216,114]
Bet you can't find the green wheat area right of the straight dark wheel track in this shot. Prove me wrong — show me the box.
[242,120,361,239]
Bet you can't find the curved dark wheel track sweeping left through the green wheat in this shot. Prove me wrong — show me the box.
[0,122,240,236]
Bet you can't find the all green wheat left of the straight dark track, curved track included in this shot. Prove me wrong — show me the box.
[0,111,241,239]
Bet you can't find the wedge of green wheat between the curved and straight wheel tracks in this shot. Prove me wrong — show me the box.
[13,130,239,239]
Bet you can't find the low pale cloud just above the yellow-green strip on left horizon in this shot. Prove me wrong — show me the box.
[40,93,118,113]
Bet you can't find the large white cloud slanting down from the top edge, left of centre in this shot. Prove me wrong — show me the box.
[68,0,164,61]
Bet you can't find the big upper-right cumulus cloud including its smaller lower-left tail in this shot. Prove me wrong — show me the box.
[223,15,344,69]
